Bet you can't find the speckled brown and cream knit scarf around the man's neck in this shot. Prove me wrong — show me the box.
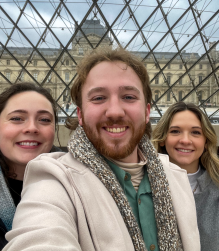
[68,126,183,251]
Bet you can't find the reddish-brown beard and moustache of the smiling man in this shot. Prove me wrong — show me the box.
[82,115,146,160]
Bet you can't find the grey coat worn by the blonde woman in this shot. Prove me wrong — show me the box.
[194,171,219,251]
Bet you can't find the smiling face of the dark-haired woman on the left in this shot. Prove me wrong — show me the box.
[0,91,55,173]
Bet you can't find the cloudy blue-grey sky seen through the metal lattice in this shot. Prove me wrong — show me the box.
[0,0,219,54]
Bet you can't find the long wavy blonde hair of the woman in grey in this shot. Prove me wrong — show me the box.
[152,102,219,185]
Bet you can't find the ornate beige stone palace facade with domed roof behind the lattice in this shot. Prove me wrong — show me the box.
[0,20,219,107]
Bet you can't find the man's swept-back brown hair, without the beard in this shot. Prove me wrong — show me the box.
[66,48,152,138]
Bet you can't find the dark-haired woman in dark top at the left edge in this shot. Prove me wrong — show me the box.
[0,83,60,250]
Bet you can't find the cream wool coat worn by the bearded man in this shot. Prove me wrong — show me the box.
[3,153,200,251]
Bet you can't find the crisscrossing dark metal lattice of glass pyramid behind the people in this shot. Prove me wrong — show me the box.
[0,0,219,123]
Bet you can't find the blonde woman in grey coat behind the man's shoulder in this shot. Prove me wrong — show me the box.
[153,102,219,251]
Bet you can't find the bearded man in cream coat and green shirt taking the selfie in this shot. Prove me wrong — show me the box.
[4,49,200,251]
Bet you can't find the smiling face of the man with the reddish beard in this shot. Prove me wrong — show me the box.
[77,61,150,163]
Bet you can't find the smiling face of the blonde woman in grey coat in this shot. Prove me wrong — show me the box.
[161,111,206,173]
